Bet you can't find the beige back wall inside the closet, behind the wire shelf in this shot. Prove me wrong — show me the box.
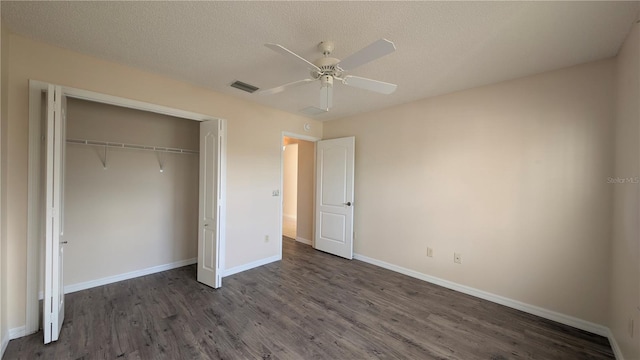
[64,99,200,285]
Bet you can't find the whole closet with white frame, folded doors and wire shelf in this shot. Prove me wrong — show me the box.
[25,80,226,343]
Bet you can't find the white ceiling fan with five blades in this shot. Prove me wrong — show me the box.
[259,39,398,114]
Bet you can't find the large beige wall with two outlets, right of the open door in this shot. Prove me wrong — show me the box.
[324,60,615,324]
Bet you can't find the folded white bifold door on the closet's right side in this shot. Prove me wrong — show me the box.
[198,120,225,288]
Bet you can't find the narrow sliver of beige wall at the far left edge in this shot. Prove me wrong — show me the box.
[0,21,9,348]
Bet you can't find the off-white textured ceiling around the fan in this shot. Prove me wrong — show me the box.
[1,1,640,120]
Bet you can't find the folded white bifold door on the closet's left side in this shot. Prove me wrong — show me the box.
[42,85,66,344]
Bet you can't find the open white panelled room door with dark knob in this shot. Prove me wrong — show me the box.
[315,137,355,259]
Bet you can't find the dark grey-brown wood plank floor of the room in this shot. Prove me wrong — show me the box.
[4,240,614,360]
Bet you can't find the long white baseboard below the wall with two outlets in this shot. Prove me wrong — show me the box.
[353,254,611,337]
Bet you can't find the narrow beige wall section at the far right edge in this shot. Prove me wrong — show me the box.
[609,20,640,359]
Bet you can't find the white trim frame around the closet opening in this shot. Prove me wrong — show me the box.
[24,79,227,335]
